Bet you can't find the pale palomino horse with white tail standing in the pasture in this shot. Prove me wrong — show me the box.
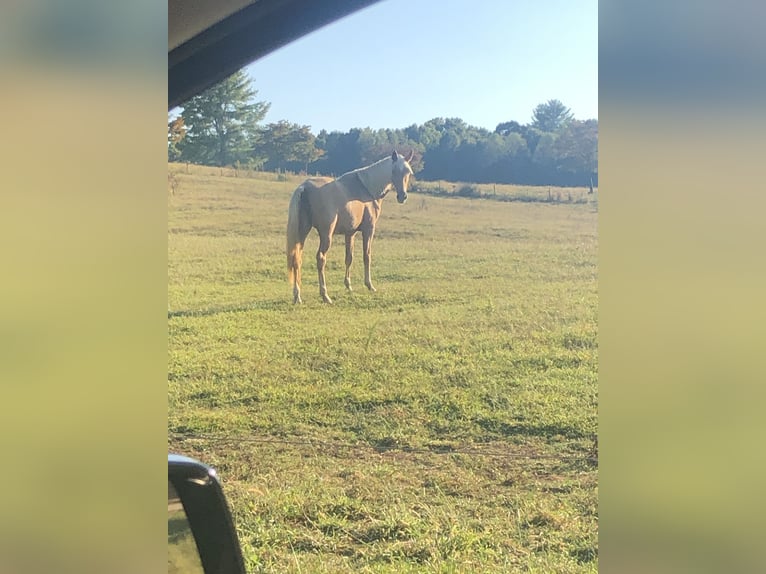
[287,151,413,303]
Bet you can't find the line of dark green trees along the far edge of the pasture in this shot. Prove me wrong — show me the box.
[168,71,598,186]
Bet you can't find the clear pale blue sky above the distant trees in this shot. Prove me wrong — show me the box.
[246,0,598,133]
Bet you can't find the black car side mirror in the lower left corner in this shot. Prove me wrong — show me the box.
[168,454,245,574]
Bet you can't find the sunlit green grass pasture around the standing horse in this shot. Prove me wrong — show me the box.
[168,165,598,573]
